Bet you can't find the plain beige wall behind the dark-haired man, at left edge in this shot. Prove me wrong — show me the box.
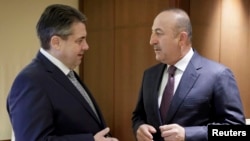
[0,0,78,140]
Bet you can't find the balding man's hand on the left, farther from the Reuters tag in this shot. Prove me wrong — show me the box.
[136,124,156,141]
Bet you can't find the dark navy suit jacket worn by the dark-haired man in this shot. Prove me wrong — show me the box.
[7,52,106,141]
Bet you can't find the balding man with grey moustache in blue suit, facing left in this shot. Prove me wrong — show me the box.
[132,9,245,141]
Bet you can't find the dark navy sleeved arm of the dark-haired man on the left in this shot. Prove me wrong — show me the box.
[8,75,94,141]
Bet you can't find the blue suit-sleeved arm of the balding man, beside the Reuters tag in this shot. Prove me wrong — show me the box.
[184,68,245,141]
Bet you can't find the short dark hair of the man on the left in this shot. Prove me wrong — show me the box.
[36,4,87,50]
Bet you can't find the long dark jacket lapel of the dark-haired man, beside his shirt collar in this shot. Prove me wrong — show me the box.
[37,52,102,123]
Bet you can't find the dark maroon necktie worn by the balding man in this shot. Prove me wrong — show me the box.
[160,66,176,122]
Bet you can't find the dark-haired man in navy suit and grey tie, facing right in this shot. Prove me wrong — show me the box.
[7,4,117,141]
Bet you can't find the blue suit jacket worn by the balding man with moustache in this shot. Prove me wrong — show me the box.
[132,52,245,141]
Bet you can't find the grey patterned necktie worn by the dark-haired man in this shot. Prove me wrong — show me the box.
[67,71,99,119]
